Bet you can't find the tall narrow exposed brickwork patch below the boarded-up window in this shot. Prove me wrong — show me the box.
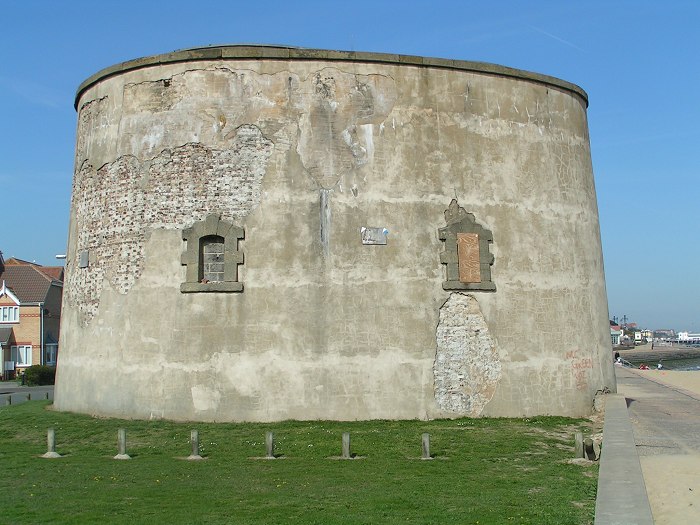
[433,293,501,417]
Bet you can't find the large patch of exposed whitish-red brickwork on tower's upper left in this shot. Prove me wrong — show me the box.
[64,125,273,324]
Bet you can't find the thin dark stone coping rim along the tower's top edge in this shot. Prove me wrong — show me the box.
[74,44,588,110]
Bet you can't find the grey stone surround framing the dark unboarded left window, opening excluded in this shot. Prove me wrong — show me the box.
[180,214,245,293]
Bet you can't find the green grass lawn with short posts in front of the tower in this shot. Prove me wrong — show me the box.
[0,401,598,525]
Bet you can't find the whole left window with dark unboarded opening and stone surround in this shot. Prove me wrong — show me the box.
[180,214,245,293]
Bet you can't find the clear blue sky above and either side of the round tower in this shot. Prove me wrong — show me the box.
[0,0,700,331]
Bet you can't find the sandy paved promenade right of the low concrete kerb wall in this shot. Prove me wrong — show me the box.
[615,367,700,525]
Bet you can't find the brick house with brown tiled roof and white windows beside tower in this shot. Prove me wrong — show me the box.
[0,252,63,378]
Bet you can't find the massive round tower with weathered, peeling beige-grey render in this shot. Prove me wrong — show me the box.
[55,46,615,421]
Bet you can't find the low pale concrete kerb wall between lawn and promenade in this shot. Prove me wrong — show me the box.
[595,394,654,525]
